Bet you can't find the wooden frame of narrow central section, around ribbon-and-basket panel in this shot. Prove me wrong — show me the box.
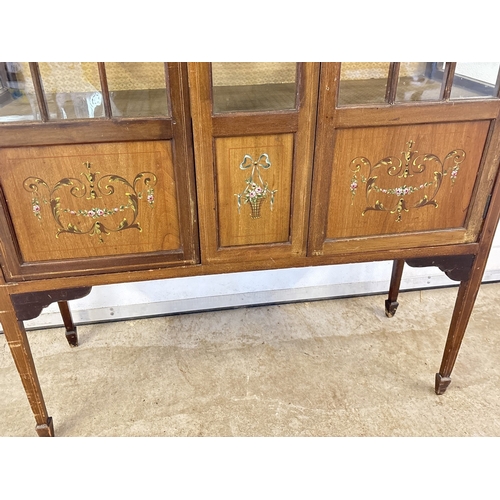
[188,63,319,263]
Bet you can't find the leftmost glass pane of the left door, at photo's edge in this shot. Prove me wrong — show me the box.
[0,62,40,122]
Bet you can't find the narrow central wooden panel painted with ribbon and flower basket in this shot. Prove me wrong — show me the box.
[215,134,293,247]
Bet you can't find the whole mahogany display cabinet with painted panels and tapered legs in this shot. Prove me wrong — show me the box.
[0,63,500,436]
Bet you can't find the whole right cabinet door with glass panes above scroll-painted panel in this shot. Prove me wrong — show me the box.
[309,63,500,257]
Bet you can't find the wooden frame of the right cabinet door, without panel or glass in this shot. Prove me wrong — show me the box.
[308,63,500,258]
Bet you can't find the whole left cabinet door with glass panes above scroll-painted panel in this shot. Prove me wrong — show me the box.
[0,63,199,279]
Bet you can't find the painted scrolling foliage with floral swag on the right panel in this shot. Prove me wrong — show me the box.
[350,140,466,222]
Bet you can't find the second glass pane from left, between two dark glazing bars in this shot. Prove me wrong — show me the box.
[39,62,104,120]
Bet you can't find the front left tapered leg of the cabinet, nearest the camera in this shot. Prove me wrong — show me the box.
[0,290,54,437]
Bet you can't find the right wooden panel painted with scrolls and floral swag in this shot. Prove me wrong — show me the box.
[327,121,489,240]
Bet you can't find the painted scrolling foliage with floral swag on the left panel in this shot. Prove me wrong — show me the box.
[23,161,157,243]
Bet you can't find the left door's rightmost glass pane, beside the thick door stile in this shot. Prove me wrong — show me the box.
[105,62,170,116]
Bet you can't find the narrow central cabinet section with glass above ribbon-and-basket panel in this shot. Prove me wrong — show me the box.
[189,63,319,265]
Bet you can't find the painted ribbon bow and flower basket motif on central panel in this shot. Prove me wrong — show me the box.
[235,153,277,219]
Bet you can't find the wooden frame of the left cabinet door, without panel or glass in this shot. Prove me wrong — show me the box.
[0,63,200,281]
